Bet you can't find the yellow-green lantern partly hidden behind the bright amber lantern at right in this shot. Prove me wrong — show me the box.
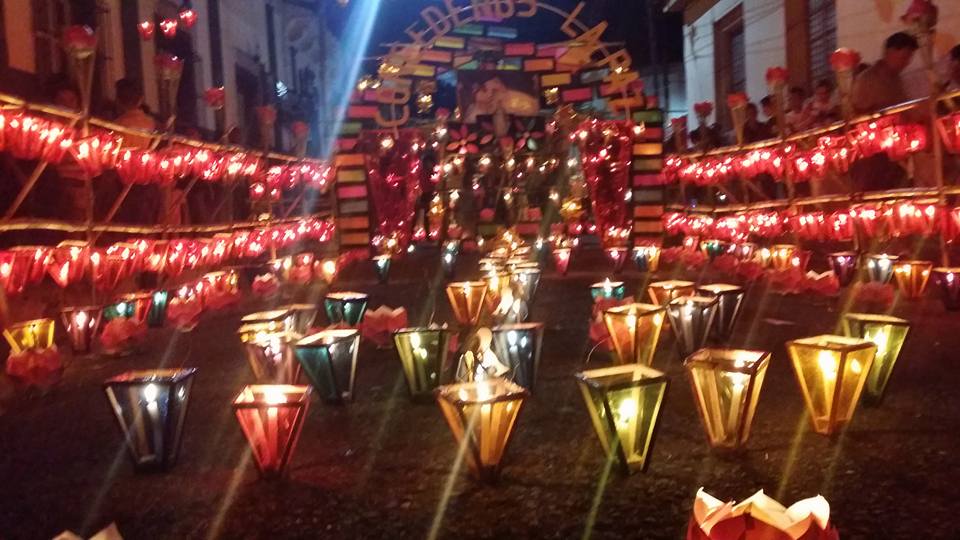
[843,313,910,405]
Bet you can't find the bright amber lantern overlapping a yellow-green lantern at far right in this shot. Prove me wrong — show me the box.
[787,335,877,435]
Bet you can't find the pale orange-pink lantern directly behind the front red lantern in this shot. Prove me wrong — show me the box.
[237,323,300,384]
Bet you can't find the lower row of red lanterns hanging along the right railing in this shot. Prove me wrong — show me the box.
[663,201,948,241]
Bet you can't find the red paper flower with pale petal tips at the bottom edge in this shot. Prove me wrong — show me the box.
[687,488,840,540]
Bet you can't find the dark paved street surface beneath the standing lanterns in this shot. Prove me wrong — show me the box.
[0,248,960,539]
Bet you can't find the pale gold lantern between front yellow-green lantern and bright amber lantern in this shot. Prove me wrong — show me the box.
[683,349,770,448]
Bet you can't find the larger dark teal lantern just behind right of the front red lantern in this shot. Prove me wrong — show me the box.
[295,329,360,403]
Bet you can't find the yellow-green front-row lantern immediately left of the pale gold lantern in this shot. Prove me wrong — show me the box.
[576,364,667,474]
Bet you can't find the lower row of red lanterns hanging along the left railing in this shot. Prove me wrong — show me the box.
[0,219,334,294]
